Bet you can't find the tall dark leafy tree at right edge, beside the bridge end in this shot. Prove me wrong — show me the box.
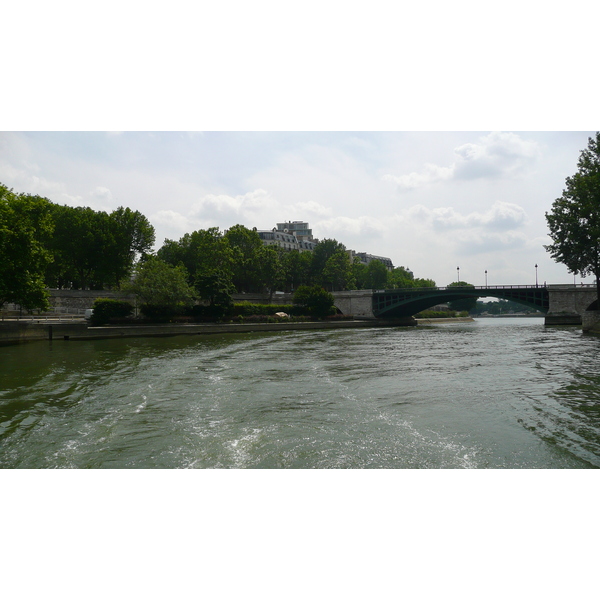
[544,132,600,300]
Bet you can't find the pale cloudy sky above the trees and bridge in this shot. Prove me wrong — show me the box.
[0,131,594,286]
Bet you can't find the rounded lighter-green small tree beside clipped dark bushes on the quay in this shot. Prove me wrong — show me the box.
[122,256,196,314]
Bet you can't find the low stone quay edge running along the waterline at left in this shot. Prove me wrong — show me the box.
[0,319,417,345]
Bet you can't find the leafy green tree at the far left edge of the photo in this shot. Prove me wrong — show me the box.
[0,184,52,310]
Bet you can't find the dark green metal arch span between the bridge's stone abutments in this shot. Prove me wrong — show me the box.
[373,285,549,319]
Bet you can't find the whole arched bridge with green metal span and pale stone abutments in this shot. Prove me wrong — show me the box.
[333,285,597,325]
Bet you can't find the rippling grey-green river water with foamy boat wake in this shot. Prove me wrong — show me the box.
[0,318,600,469]
